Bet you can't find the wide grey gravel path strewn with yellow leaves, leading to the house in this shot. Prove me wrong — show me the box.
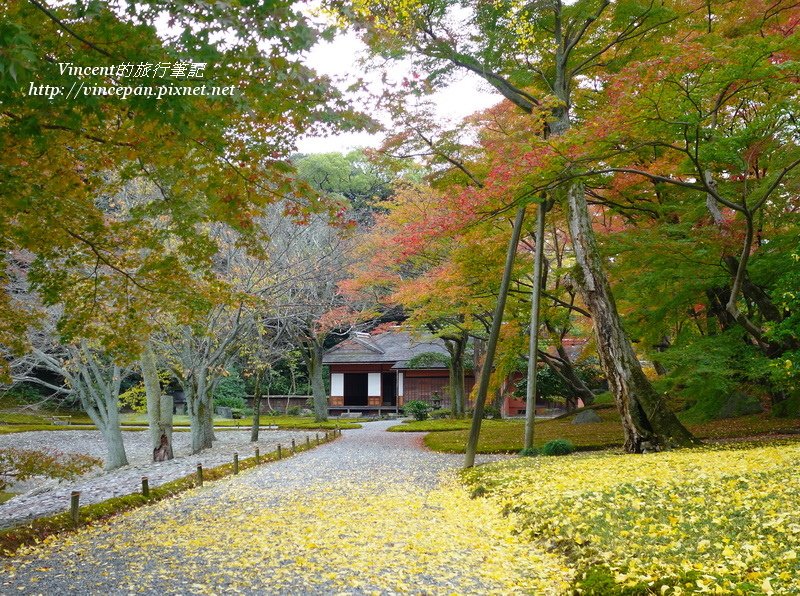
[0,422,570,594]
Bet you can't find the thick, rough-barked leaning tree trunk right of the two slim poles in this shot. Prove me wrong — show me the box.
[567,182,693,453]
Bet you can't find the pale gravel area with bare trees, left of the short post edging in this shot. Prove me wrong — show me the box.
[0,429,315,529]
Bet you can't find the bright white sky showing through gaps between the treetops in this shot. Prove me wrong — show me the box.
[297,33,502,153]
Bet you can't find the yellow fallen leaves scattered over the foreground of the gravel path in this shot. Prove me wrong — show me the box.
[4,474,572,594]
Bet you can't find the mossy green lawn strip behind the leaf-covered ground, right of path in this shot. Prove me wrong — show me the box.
[390,406,800,453]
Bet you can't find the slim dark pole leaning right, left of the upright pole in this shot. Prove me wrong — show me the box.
[464,207,525,468]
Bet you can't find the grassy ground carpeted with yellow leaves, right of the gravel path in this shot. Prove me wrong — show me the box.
[466,443,800,594]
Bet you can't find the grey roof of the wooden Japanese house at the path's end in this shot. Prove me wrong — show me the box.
[322,330,448,368]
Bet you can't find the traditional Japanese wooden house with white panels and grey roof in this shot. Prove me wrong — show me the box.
[322,328,475,414]
